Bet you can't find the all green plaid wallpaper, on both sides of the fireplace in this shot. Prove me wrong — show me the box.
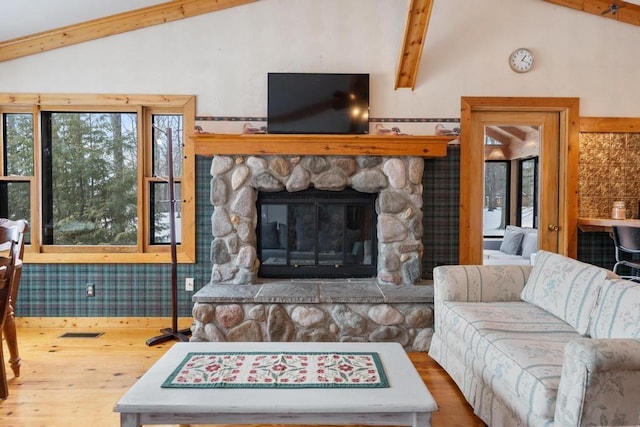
[16,150,614,317]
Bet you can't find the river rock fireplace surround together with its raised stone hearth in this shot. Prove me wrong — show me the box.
[191,155,433,351]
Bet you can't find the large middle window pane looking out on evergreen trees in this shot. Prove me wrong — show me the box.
[41,111,138,246]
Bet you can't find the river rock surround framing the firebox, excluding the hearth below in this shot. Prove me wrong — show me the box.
[210,156,424,285]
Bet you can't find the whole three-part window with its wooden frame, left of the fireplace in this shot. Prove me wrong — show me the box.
[0,94,195,263]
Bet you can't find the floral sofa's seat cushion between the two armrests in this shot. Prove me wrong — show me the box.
[436,302,580,419]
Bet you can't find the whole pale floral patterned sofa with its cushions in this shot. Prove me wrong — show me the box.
[429,251,640,426]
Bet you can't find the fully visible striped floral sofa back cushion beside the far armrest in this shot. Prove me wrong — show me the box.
[520,250,607,335]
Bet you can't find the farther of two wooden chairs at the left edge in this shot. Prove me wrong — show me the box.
[0,218,29,377]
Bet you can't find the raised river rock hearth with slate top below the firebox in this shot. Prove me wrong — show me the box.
[191,279,433,351]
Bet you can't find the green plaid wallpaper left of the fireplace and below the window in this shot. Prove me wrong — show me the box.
[16,156,213,317]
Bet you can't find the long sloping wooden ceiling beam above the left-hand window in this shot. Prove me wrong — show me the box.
[0,0,257,61]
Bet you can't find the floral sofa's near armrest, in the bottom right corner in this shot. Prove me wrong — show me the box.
[555,338,640,426]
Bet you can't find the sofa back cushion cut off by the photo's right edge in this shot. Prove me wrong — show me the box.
[589,280,640,339]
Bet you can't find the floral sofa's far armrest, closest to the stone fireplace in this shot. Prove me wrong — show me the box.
[433,265,532,310]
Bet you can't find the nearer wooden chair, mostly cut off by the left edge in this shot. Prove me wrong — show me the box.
[0,227,20,399]
